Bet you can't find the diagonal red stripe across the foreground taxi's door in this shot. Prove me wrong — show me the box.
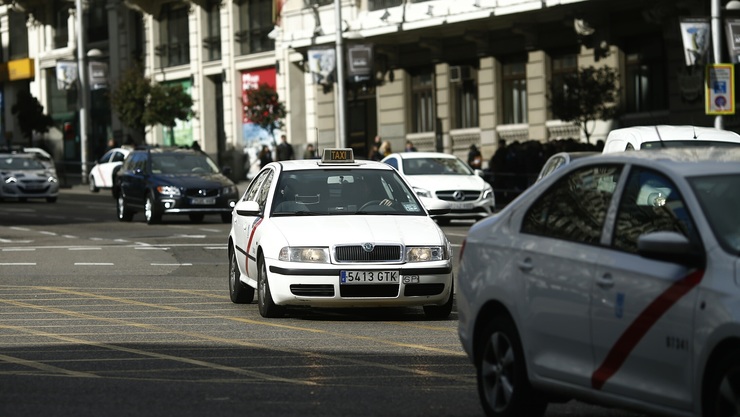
[591,270,704,389]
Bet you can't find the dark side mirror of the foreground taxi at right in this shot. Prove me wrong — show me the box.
[637,232,705,267]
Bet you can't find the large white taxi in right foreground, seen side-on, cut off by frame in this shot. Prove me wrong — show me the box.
[456,148,740,417]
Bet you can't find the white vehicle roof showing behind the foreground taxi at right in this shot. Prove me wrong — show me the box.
[604,125,740,153]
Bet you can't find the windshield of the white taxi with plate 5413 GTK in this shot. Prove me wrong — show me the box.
[271,169,426,216]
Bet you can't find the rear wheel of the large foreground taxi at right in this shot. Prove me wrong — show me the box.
[475,316,547,417]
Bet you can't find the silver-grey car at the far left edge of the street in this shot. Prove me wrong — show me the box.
[0,152,59,203]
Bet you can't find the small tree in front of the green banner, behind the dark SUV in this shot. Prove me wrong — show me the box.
[142,84,194,138]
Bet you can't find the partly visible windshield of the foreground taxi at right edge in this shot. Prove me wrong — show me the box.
[689,175,740,255]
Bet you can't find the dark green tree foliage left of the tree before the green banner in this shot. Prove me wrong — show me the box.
[110,65,152,132]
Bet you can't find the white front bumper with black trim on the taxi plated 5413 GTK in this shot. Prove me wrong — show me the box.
[268,262,452,307]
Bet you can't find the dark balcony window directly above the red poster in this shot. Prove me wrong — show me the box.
[235,0,275,55]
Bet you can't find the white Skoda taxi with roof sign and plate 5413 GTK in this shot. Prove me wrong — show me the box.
[228,149,453,319]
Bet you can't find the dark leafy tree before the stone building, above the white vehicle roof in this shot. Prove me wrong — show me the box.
[550,66,619,143]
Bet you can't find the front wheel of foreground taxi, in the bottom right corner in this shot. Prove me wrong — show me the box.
[702,350,740,417]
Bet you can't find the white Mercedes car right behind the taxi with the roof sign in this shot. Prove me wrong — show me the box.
[381,152,496,224]
